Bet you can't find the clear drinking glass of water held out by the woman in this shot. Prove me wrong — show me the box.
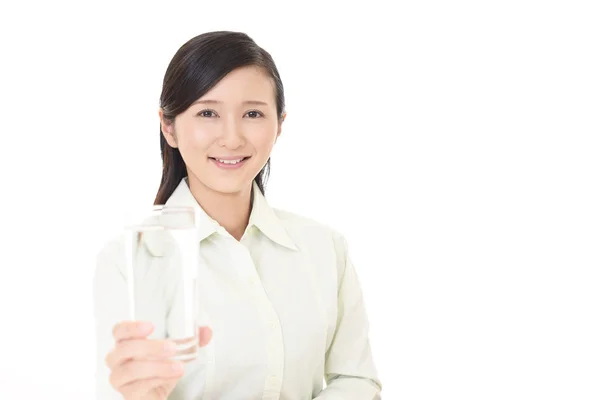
[125,206,199,361]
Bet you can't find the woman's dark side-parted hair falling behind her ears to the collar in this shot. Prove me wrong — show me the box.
[154,31,285,205]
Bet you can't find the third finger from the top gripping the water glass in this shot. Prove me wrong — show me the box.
[110,360,184,391]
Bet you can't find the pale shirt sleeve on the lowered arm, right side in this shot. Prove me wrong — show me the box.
[315,235,381,400]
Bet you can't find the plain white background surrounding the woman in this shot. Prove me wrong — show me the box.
[0,1,600,400]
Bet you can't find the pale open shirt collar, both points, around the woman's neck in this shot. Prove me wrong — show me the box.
[165,178,298,250]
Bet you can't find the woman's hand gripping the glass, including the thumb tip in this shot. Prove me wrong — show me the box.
[106,321,212,400]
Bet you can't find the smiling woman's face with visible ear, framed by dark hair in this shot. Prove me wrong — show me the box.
[159,66,283,194]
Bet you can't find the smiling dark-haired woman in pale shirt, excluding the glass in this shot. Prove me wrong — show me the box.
[95,32,381,400]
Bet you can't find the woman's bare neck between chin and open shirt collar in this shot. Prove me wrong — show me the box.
[188,176,252,240]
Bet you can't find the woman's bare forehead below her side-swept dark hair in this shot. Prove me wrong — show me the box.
[201,66,275,103]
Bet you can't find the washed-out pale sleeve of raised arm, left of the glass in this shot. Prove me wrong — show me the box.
[93,241,129,400]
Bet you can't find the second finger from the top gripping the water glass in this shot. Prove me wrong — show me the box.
[105,339,177,369]
